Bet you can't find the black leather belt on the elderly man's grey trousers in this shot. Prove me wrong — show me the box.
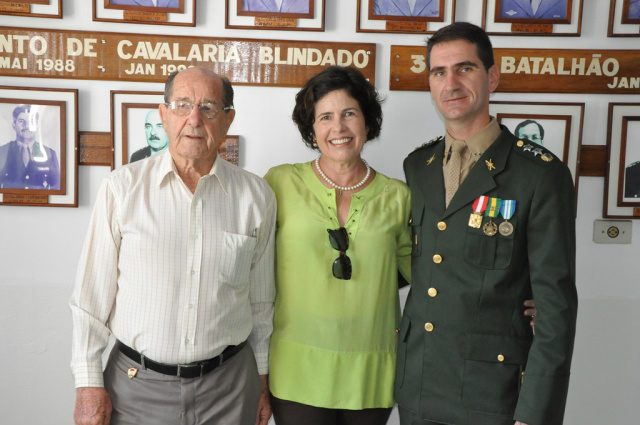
[115,341,247,378]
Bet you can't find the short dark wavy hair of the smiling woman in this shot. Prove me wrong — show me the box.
[291,66,382,149]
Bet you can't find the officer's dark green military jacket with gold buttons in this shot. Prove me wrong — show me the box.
[395,127,577,425]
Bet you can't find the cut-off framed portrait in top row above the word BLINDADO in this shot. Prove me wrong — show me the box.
[225,0,325,31]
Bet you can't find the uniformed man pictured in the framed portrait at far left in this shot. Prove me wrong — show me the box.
[0,105,60,190]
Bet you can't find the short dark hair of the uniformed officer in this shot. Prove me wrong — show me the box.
[427,22,495,72]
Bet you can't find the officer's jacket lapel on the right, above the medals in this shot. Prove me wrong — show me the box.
[440,131,511,218]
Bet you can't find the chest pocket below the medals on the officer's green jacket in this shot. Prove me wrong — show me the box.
[464,217,518,270]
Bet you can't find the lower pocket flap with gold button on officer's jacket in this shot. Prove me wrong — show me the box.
[466,334,531,365]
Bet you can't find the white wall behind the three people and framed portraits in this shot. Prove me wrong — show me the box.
[0,0,640,425]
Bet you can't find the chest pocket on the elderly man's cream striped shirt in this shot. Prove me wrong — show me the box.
[218,232,256,286]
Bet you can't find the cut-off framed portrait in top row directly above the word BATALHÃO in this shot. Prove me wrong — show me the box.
[482,0,583,36]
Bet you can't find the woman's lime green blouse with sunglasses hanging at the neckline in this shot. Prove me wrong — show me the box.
[265,163,411,410]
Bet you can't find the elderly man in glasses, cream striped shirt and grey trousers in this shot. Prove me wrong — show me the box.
[70,68,276,425]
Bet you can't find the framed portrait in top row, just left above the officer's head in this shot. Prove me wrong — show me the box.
[356,0,456,34]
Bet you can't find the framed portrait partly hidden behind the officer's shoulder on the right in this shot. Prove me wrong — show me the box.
[489,102,584,189]
